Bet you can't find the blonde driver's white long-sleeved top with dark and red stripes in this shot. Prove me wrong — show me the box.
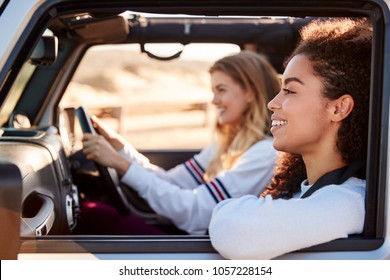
[121,138,277,234]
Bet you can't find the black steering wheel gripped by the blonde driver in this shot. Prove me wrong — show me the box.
[75,106,130,216]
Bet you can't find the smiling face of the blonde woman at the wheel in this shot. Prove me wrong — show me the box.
[211,71,252,126]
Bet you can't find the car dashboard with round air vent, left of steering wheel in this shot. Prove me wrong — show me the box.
[0,127,80,237]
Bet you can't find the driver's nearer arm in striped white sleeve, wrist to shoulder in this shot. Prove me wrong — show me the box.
[122,141,276,234]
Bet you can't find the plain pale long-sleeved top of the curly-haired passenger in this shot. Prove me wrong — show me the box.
[209,178,366,259]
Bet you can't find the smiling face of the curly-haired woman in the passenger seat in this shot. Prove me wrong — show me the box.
[268,54,334,155]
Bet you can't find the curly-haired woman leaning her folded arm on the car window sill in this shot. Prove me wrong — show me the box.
[209,19,372,259]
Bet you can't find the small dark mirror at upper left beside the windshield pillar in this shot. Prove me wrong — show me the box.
[30,36,58,65]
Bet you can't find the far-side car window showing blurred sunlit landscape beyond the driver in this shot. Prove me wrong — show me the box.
[60,44,239,149]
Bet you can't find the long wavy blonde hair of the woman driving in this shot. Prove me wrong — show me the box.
[205,51,280,181]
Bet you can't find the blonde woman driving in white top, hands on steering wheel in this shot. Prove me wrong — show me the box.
[83,51,280,234]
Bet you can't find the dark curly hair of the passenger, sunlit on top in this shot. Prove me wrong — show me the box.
[262,18,372,198]
